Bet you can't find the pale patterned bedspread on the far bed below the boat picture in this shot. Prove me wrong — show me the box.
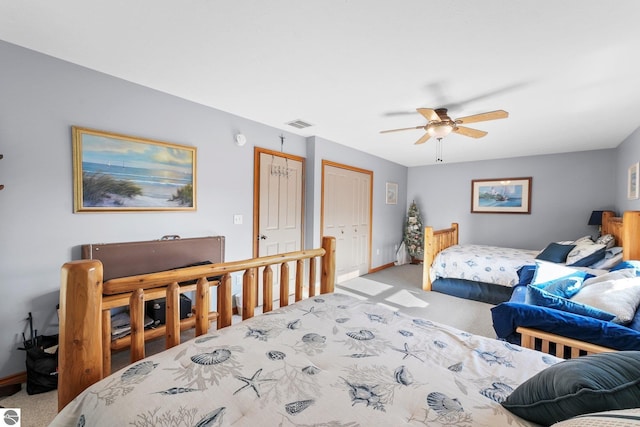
[430,245,540,287]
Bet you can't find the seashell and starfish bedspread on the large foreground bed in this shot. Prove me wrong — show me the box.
[51,293,560,427]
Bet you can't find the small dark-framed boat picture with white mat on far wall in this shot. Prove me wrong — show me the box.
[471,177,531,214]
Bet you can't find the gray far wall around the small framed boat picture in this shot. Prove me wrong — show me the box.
[407,150,617,249]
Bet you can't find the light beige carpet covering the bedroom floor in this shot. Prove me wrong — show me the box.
[0,264,495,427]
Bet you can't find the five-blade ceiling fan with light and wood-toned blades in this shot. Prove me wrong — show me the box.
[380,108,509,144]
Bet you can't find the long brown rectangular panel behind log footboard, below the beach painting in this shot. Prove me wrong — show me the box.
[82,236,225,281]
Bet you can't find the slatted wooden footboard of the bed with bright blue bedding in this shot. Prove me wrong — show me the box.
[516,326,617,359]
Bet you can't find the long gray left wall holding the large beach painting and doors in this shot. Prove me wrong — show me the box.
[0,41,407,378]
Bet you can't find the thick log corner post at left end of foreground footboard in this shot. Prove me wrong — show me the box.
[58,260,102,410]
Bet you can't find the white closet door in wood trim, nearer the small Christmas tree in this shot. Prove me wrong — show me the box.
[322,162,372,283]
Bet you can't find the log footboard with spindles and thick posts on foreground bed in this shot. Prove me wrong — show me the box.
[58,237,335,410]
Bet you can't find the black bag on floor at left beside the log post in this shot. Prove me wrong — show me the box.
[25,335,58,394]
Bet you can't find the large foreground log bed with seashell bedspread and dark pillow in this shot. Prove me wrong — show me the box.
[51,219,640,426]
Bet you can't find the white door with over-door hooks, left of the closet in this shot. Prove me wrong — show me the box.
[256,151,304,301]
